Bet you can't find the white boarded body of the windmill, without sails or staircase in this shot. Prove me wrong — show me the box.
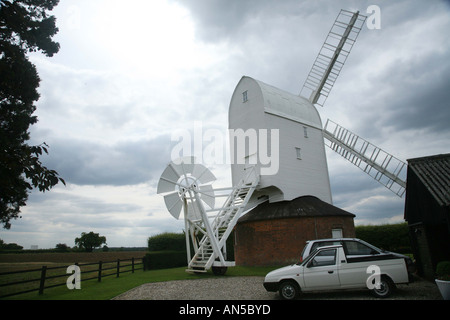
[228,76,332,204]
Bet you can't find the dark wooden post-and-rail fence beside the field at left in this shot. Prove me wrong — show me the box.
[0,258,145,298]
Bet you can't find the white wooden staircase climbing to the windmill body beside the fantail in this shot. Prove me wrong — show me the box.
[186,167,259,272]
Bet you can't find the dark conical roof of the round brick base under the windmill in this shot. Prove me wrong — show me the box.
[238,196,355,223]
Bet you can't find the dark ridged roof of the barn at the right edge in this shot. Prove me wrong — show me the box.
[408,153,450,206]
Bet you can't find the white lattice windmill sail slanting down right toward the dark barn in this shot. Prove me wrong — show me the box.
[323,120,407,197]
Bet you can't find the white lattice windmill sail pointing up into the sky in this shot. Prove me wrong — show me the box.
[300,10,366,106]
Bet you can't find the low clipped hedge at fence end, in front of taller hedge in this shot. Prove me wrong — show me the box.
[143,251,187,270]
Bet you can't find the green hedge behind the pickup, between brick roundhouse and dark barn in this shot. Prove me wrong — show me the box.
[355,223,412,253]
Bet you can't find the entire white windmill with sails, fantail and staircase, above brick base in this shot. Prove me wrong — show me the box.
[157,10,406,273]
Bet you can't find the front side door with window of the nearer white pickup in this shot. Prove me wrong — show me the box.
[303,248,340,290]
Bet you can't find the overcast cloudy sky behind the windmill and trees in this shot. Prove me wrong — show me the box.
[0,0,450,249]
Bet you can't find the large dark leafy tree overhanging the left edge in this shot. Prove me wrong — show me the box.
[0,0,65,229]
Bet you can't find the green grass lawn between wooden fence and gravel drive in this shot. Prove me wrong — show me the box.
[7,267,277,300]
